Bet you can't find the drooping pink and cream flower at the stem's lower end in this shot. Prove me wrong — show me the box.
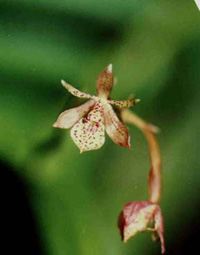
[118,201,165,254]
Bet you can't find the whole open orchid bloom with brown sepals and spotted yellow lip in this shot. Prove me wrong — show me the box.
[53,64,140,152]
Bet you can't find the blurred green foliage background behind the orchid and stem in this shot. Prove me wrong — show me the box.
[0,0,200,255]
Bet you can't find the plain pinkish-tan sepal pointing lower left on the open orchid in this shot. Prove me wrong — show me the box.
[53,100,95,129]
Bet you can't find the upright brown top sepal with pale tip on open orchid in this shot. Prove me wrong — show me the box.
[96,64,114,98]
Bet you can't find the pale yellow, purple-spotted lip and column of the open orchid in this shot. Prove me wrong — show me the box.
[70,103,105,152]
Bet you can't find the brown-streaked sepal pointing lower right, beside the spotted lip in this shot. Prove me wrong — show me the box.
[104,104,131,148]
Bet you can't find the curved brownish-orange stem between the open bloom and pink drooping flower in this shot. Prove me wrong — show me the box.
[121,109,162,204]
